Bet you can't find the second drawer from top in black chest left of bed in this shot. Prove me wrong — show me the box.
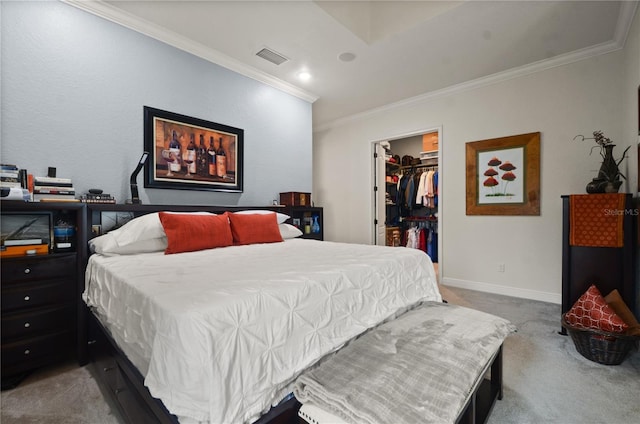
[1,278,76,313]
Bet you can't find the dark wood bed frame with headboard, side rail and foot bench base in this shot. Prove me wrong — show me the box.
[78,204,502,424]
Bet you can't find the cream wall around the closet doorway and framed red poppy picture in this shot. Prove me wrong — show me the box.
[314,16,638,303]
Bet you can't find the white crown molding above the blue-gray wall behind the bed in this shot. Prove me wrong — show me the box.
[60,0,318,103]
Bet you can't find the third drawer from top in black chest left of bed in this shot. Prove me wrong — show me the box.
[2,305,76,344]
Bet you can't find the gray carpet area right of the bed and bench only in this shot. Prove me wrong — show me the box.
[443,287,640,424]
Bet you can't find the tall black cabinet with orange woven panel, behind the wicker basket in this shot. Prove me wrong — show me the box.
[562,194,640,334]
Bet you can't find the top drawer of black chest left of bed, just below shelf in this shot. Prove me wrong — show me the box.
[1,253,76,286]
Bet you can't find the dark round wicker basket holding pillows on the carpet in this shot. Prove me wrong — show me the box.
[562,314,640,365]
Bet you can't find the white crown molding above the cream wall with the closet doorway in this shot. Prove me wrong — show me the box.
[313,1,638,132]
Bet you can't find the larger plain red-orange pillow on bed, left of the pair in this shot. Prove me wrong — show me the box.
[159,212,233,255]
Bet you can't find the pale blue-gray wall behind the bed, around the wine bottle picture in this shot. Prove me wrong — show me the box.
[0,2,312,205]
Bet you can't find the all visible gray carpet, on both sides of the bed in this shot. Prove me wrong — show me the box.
[0,287,640,424]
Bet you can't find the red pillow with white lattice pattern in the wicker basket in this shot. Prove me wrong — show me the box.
[565,285,629,333]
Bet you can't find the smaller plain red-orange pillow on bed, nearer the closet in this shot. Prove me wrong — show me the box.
[229,212,282,244]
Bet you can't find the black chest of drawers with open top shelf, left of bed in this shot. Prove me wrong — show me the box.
[1,201,86,388]
